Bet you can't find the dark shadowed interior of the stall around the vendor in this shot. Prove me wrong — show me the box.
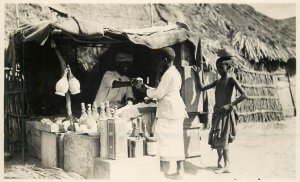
[21,41,179,117]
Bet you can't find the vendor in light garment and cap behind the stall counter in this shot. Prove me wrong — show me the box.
[95,52,134,108]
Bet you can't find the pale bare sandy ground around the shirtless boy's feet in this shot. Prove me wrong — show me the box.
[4,118,296,181]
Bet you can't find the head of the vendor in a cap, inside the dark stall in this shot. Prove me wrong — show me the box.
[115,52,133,75]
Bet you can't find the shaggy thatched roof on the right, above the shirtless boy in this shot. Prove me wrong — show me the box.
[156,4,296,67]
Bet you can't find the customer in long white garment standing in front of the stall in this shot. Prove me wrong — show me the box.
[134,47,187,178]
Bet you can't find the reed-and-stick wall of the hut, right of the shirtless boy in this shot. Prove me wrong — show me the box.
[236,70,284,122]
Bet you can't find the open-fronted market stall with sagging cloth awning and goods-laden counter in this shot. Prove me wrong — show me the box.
[6,17,203,178]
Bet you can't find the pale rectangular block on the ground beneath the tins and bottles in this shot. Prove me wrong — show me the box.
[94,156,160,181]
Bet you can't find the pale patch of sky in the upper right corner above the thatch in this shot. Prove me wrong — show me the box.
[249,4,296,19]
